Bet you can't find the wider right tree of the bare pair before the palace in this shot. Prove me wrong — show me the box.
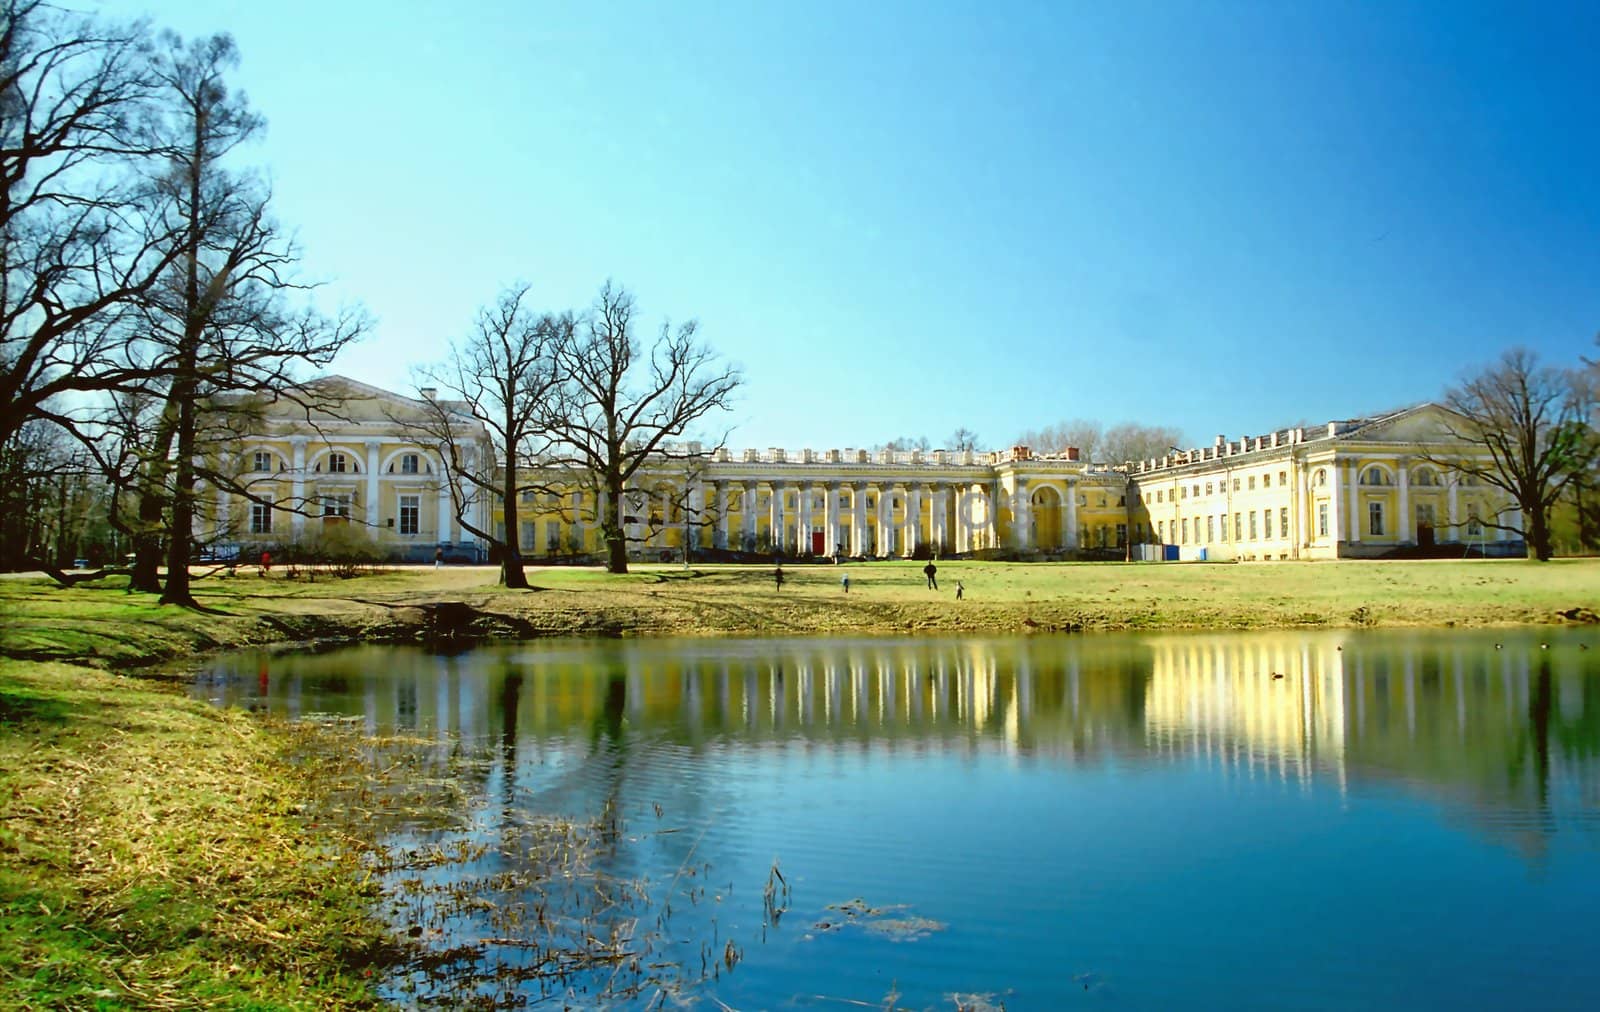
[542,282,742,573]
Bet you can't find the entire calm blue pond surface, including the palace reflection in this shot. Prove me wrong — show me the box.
[195,629,1600,1009]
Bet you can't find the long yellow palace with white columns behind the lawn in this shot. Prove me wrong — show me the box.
[209,376,1523,562]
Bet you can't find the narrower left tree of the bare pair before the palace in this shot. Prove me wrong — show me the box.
[409,285,574,589]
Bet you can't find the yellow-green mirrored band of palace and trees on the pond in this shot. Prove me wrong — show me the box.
[219,633,1600,836]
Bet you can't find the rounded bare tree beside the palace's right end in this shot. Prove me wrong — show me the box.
[1429,347,1600,562]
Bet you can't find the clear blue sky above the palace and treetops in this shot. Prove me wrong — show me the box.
[99,0,1600,448]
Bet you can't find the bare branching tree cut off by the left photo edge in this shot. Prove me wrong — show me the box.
[0,0,179,442]
